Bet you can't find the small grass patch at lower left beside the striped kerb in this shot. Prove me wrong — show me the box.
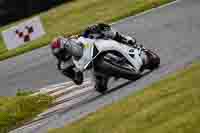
[0,93,53,133]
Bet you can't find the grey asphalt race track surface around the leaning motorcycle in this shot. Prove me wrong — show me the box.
[0,0,200,133]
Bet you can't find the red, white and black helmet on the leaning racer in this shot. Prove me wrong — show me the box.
[51,37,70,61]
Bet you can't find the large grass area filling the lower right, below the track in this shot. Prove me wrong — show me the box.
[49,63,200,133]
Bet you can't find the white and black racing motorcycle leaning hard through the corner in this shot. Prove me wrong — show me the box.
[58,38,160,93]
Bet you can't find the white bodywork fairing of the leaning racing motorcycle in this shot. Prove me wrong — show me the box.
[73,37,143,73]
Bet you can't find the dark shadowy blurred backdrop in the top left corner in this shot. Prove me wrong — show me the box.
[0,0,71,25]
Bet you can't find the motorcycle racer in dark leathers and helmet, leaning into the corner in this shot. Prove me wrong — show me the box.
[51,23,148,84]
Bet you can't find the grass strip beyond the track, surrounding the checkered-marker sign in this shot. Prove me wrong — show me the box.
[0,0,173,60]
